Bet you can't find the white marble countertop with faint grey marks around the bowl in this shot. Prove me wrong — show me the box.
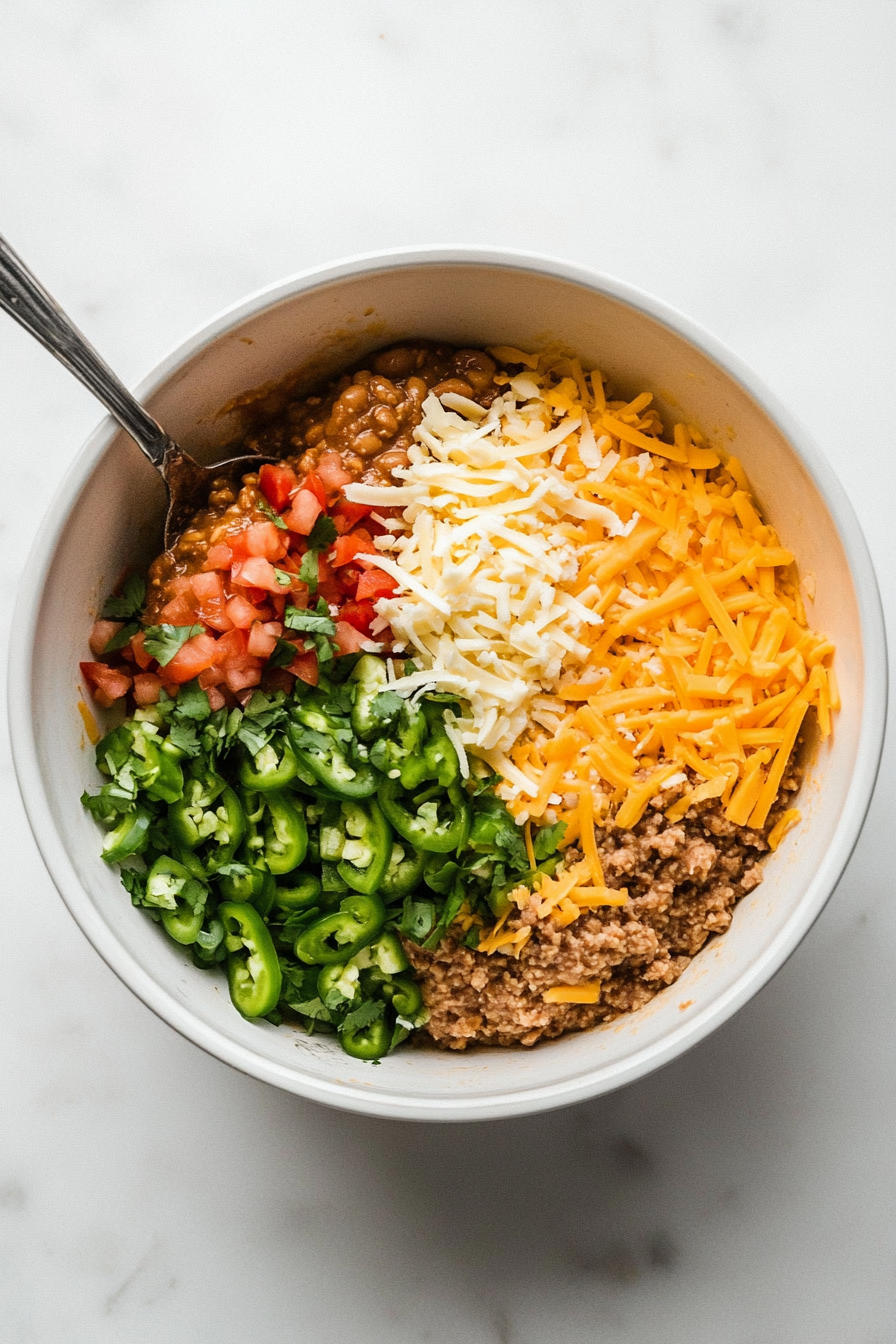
[0,0,896,1344]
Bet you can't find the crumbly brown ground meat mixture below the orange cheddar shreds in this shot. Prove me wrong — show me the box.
[406,769,799,1050]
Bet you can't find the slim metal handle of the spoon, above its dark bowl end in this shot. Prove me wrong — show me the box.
[0,235,173,470]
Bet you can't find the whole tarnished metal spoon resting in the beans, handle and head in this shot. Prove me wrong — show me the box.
[0,235,275,547]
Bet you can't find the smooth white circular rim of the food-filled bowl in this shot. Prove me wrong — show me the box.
[7,245,888,1121]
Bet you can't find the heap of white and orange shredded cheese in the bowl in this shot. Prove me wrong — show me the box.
[345,347,840,946]
